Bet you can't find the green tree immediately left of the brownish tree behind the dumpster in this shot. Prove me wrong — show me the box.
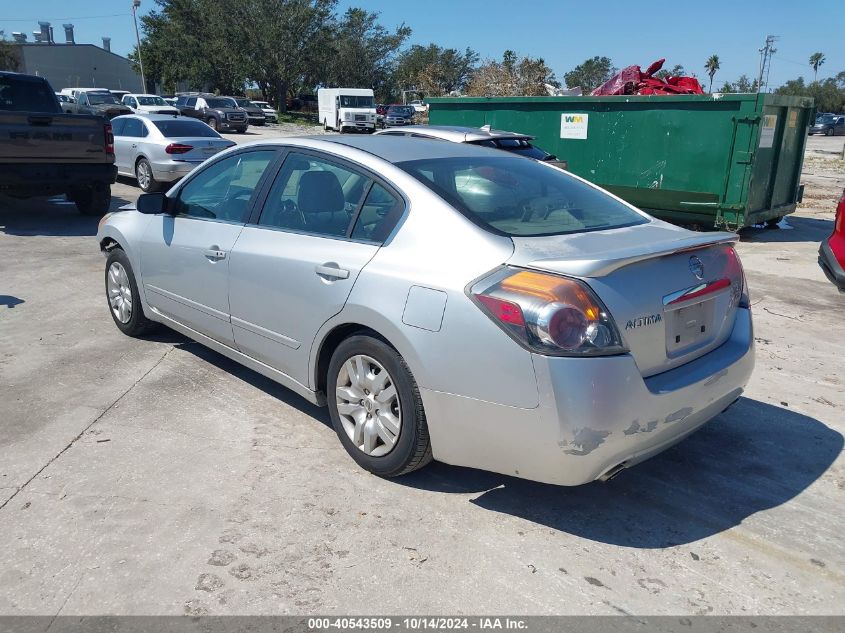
[394,44,478,97]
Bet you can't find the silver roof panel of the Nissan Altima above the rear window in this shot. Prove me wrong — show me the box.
[320,134,502,163]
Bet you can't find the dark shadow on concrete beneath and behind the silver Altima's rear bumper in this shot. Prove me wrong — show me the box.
[393,398,843,549]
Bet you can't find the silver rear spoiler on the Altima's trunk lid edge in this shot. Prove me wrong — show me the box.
[529,232,739,277]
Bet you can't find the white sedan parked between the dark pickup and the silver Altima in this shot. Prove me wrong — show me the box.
[112,114,235,191]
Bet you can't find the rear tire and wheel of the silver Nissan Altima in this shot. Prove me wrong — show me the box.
[326,335,432,477]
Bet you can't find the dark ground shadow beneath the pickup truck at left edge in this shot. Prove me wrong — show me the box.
[0,196,129,237]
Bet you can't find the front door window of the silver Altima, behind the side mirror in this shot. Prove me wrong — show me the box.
[174,150,276,222]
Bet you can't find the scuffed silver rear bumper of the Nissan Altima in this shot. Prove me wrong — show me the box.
[421,309,754,485]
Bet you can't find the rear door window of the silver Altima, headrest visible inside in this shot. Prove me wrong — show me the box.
[258,152,370,237]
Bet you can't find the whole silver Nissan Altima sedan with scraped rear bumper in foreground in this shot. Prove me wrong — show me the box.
[97,136,754,485]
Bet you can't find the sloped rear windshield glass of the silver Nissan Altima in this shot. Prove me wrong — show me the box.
[397,154,648,237]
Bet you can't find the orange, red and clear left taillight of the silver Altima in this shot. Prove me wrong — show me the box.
[467,267,626,356]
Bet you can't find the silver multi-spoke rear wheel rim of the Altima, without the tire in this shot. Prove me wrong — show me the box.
[335,354,402,457]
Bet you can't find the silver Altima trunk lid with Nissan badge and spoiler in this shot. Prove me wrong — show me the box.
[508,221,743,376]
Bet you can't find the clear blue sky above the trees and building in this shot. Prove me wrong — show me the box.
[0,0,845,86]
